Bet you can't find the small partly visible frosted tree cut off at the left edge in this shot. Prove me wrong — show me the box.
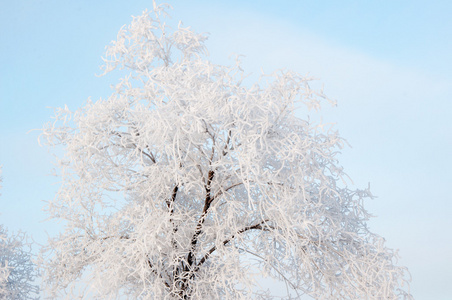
[0,166,39,300]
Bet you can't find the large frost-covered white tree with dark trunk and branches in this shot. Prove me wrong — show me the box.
[41,4,409,299]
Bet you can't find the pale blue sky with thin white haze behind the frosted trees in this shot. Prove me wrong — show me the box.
[0,0,452,299]
